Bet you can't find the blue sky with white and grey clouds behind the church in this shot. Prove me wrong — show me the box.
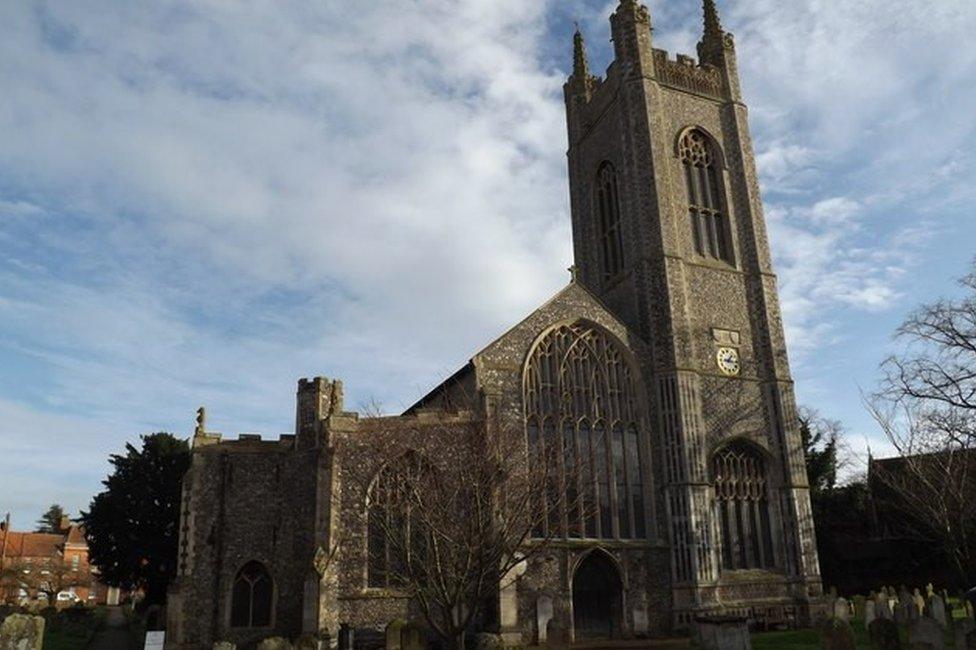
[0,0,976,528]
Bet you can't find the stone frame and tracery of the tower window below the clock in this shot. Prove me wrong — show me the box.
[708,436,779,573]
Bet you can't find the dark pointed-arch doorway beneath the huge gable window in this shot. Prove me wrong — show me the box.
[573,551,623,641]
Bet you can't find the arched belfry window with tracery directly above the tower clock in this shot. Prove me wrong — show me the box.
[678,129,733,263]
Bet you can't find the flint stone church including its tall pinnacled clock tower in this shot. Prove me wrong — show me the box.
[167,0,822,648]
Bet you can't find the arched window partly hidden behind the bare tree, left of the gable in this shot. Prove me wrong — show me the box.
[366,452,430,587]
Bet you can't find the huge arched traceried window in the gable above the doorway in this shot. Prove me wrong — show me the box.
[524,322,647,539]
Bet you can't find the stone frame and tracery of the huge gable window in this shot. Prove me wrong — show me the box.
[522,318,656,543]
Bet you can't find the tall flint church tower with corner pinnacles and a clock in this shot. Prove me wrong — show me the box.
[565,0,821,624]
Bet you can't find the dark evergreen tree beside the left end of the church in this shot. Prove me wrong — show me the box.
[81,433,190,603]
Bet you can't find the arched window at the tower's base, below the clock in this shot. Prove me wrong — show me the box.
[712,441,775,570]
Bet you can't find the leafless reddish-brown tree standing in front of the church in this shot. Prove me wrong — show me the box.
[353,419,588,650]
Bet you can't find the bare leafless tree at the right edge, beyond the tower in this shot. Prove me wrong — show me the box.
[868,260,976,581]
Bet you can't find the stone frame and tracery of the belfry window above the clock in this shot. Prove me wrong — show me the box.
[674,124,739,268]
